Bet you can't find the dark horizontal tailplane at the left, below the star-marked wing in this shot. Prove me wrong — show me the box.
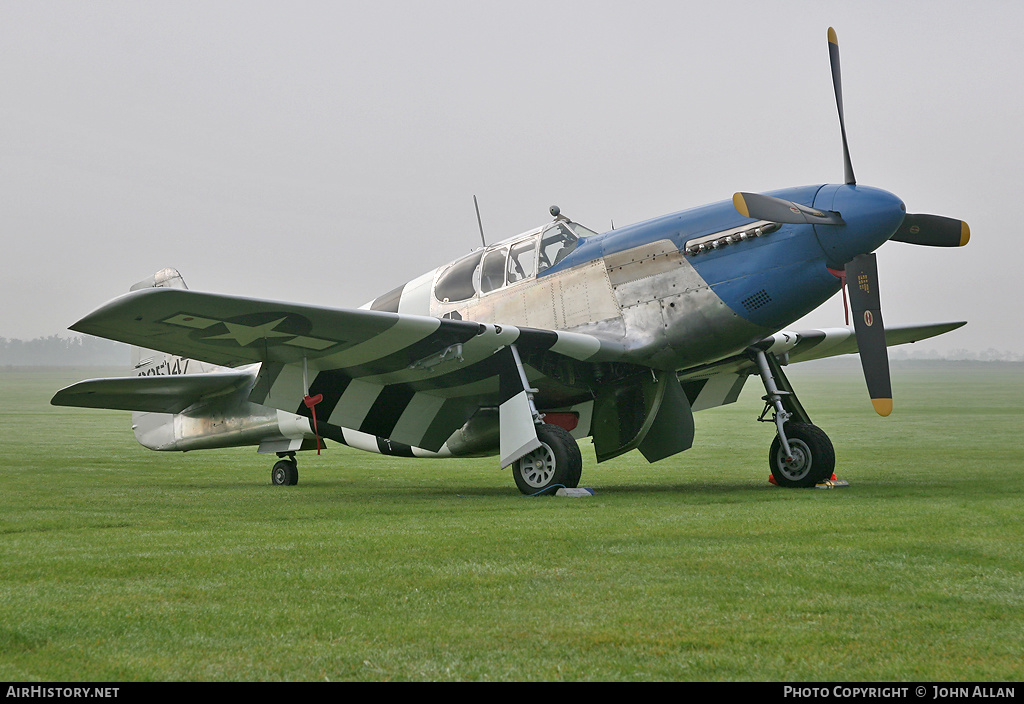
[50,371,254,413]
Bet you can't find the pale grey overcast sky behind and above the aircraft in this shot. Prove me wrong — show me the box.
[0,0,1024,351]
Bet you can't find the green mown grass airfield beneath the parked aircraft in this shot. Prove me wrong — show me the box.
[0,360,1024,683]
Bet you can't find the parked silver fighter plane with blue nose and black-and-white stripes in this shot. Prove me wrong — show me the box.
[52,29,970,493]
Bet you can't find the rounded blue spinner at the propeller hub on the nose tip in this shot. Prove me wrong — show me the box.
[814,184,906,267]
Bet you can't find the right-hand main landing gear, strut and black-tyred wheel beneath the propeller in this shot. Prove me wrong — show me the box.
[750,348,836,487]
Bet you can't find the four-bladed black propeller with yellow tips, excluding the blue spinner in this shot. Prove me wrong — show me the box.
[732,27,971,415]
